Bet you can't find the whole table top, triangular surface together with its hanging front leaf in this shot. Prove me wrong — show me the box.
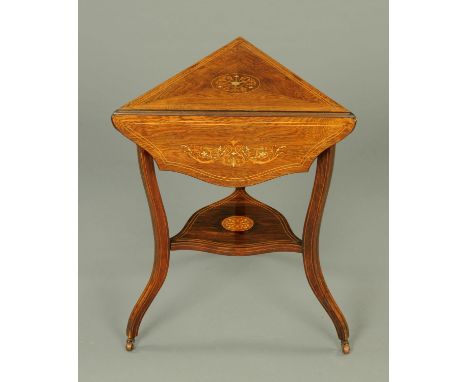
[112,37,356,187]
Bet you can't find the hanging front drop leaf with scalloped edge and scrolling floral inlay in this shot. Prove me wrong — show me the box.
[112,114,356,187]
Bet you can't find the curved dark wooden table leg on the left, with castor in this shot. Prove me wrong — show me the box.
[126,147,170,351]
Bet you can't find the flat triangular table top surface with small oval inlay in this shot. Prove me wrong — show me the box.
[119,37,349,113]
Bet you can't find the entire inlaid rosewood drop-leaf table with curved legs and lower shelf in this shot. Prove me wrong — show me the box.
[112,37,356,354]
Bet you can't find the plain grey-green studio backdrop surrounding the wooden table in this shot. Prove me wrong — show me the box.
[79,0,388,382]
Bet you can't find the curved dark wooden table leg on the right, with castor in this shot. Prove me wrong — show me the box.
[303,146,350,354]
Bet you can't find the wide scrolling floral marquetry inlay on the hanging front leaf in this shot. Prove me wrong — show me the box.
[181,140,286,167]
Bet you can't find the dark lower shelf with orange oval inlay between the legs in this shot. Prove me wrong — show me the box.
[171,188,302,256]
